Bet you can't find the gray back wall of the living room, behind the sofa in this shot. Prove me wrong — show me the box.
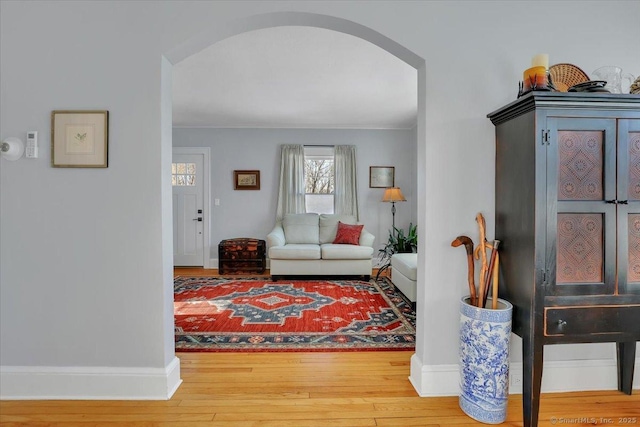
[173,128,417,259]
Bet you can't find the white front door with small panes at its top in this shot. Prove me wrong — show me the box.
[171,149,208,266]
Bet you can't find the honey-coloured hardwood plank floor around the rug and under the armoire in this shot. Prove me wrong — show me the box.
[0,271,640,427]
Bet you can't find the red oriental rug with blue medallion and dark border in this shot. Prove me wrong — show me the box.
[174,276,415,352]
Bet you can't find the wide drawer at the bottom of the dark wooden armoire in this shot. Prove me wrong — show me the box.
[544,305,640,336]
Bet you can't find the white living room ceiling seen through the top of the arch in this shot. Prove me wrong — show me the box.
[173,26,417,129]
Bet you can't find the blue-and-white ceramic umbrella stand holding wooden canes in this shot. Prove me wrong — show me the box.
[451,213,513,424]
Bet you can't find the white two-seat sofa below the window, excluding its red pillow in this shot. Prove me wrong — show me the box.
[267,213,375,280]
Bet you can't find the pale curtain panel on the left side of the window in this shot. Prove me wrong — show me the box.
[276,145,306,221]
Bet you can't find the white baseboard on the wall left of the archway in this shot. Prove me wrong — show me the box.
[0,357,182,400]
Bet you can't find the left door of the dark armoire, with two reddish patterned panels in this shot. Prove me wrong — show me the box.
[547,117,616,296]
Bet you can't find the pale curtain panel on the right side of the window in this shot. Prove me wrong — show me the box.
[335,145,360,221]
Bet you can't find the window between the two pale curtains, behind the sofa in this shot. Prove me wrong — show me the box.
[304,146,335,214]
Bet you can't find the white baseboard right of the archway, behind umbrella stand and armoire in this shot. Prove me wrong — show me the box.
[409,354,640,397]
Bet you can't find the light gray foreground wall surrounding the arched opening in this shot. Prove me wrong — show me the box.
[0,1,640,396]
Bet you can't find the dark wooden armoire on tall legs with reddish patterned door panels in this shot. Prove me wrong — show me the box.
[488,92,640,427]
